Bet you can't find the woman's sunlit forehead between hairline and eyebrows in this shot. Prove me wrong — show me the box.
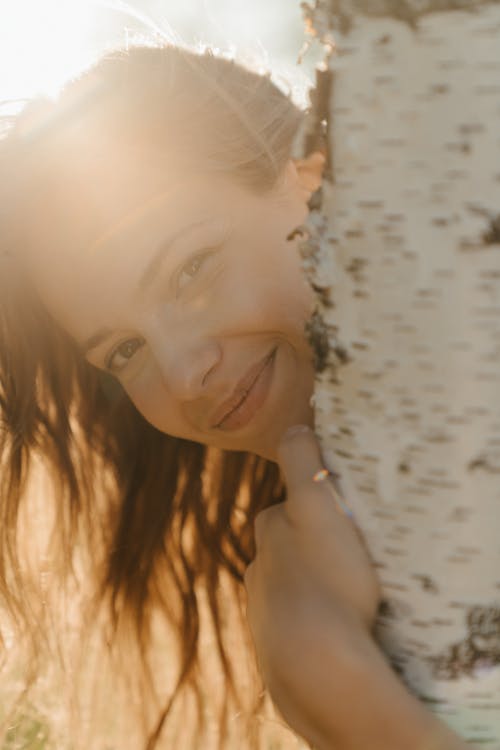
[17,145,262,335]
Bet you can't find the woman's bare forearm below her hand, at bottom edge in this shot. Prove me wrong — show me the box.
[307,633,468,750]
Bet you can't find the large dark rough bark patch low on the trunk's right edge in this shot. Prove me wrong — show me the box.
[429,605,500,680]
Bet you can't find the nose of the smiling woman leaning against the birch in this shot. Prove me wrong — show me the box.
[154,338,222,401]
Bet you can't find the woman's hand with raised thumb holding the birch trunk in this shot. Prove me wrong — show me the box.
[245,428,380,740]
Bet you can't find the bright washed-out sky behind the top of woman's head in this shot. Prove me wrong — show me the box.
[0,0,321,113]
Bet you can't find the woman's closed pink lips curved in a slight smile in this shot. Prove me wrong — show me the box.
[211,347,277,429]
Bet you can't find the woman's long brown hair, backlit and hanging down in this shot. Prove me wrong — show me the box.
[0,46,304,750]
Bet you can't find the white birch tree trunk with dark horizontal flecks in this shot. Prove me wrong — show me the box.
[297,0,500,750]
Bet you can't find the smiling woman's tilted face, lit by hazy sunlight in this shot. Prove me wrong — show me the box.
[29,150,322,459]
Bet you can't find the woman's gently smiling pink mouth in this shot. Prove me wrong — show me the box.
[213,347,277,431]
